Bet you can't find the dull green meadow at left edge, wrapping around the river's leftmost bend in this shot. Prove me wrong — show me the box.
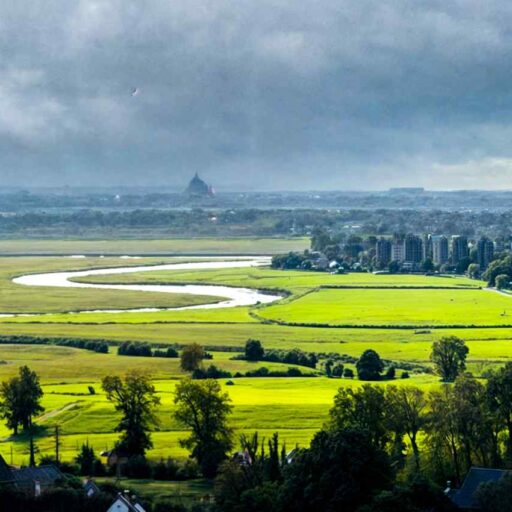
[0,257,222,314]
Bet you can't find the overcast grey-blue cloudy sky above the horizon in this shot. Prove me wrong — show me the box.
[0,0,512,190]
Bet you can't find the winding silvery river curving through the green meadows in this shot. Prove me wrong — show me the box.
[7,257,281,317]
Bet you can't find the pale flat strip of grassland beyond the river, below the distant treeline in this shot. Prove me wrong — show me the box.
[0,237,309,255]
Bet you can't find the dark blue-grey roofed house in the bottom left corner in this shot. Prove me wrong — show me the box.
[0,455,64,496]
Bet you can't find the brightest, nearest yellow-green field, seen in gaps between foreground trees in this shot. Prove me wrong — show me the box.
[0,376,439,463]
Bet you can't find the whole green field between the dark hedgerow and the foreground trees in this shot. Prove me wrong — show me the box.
[0,346,438,463]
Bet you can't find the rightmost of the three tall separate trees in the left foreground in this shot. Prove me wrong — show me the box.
[174,378,233,477]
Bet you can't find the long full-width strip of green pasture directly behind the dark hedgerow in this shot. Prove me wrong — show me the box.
[0,323,512,362]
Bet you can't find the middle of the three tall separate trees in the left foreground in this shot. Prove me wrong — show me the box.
[102,370,160,455]
